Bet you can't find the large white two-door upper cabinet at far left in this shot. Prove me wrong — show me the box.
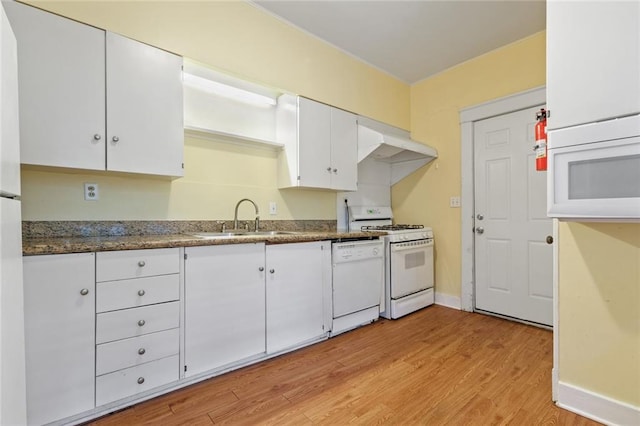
[6,2,184,176]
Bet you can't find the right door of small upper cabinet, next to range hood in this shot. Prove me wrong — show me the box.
[331,108,358,191]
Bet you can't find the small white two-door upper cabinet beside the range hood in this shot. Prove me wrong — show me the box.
[277,95,358,191]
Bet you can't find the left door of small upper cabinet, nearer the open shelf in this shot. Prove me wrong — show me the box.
[298,98,331,188]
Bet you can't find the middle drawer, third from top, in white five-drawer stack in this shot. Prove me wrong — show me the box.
[96,302,180,344]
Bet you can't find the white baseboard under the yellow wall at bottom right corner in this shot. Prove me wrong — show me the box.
[557,382,640,426]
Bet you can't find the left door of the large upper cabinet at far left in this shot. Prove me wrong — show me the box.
[3,2,105,170]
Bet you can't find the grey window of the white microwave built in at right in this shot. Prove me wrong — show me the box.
[568,155,640,200]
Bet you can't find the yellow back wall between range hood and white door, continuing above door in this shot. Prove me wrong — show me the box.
[400,32,545,297]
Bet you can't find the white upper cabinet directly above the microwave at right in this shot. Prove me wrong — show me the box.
[547,0,640,130]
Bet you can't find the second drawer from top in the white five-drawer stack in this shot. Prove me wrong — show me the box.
[96,274,180,312]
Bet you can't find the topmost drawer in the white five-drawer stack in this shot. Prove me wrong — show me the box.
[96,248,180,282]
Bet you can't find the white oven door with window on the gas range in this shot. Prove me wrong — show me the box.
[389,239,433,299]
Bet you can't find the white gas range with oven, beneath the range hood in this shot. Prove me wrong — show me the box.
[349,206,435,319]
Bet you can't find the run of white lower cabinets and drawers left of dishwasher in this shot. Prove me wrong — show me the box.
[24,241,331,424]
